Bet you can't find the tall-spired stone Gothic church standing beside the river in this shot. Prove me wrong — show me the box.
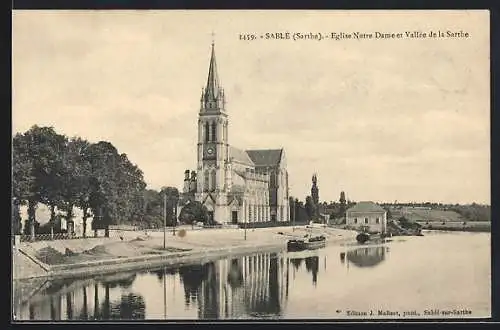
[178,43,290,224]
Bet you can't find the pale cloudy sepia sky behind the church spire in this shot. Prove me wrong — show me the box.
[12,10,490,204]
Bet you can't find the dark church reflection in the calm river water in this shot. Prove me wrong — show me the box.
[179,254,289,319]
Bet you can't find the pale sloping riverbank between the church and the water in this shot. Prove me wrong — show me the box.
[13,227,355,280]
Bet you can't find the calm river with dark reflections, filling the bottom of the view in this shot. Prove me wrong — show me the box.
[14,232,491,320]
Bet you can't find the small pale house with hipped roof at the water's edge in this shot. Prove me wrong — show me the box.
[346,202,387,233]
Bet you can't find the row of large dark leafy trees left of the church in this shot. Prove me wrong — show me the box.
[12,125,183,236]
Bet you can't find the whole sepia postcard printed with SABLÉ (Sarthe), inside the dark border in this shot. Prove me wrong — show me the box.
[11,10,491,322]
